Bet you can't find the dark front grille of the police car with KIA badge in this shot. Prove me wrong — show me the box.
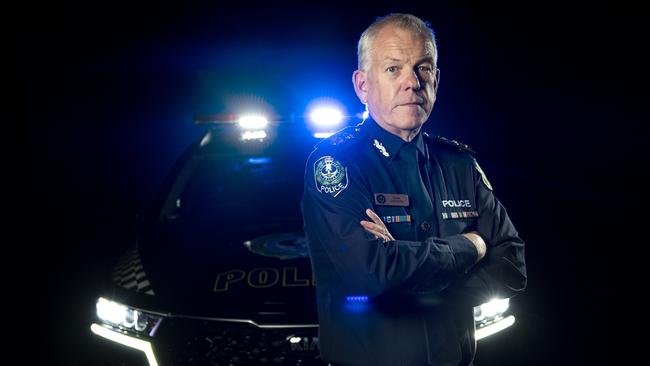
[154,318,325,366]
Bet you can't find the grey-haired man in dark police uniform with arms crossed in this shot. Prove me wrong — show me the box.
[302,14,526,365]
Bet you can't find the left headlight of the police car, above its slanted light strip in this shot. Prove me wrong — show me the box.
[97,297,162,336]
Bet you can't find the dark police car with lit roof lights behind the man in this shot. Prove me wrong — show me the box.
[90,110,515,365]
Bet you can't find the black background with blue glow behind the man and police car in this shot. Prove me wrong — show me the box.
[15,2,648,365]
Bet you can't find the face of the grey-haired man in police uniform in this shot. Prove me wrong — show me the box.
[354,25,437,136]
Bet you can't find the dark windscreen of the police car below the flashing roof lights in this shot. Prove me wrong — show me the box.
[161,154,304,232]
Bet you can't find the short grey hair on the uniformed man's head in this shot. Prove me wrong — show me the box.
[357,13,438,72]
